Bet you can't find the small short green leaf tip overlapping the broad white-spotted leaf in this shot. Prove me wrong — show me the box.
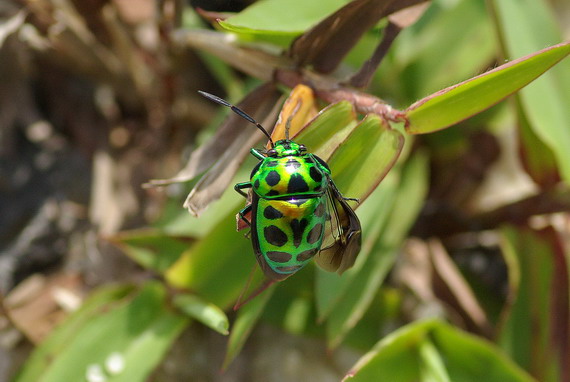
[172,294,230,335]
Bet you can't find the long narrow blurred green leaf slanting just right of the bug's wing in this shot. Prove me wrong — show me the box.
[327,154,428,347]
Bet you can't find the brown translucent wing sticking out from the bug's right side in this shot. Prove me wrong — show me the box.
[315,178,362,275]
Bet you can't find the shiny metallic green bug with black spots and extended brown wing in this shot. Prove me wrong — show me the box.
[199,91,362,283]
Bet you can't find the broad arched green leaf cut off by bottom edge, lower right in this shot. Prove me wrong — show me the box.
[343,320,534,382]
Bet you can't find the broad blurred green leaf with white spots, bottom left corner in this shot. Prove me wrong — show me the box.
[15,282,188,382]
